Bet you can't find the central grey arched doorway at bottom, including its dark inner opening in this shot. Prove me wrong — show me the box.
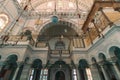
[48,61,72,80]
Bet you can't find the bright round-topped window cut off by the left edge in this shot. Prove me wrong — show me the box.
[0,13,9,32]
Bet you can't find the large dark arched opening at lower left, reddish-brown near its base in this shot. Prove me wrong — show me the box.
[0,54,18,80]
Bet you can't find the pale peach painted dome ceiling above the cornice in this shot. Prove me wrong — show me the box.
[17,0,93,13]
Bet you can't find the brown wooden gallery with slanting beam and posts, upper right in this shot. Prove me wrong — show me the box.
[82,0,120,46]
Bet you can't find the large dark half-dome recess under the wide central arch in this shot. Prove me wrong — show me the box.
[37,21,78,41]
